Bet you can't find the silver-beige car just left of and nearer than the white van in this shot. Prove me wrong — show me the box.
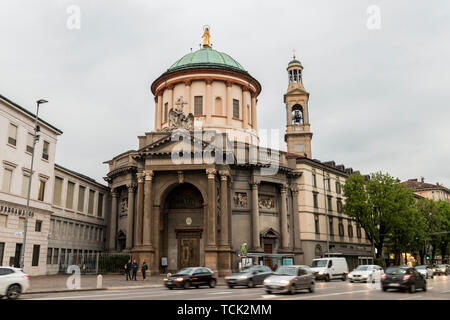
[264,265,315,294]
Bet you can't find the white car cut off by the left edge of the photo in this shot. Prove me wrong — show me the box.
[0,267,30,300]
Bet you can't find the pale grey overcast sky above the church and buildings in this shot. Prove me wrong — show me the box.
[0,0,450,187]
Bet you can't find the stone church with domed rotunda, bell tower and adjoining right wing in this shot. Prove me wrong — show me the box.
[105,29,370,276]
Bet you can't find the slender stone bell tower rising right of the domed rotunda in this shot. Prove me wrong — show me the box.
[284,55,312,158]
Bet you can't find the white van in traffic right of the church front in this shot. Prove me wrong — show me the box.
[311,257,348,281]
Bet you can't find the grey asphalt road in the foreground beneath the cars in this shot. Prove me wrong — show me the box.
[20,276,450,300]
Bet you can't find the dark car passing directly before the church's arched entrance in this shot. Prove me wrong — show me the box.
[164,267,217,289]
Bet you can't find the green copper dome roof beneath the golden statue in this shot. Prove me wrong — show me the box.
[167,48,247,73]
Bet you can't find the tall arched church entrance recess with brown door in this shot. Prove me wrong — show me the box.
[160,183,205,272]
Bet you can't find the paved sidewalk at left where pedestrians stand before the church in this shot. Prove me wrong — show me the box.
[27,274,226,293]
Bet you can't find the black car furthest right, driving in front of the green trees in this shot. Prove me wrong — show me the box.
[381,266,427,293]
